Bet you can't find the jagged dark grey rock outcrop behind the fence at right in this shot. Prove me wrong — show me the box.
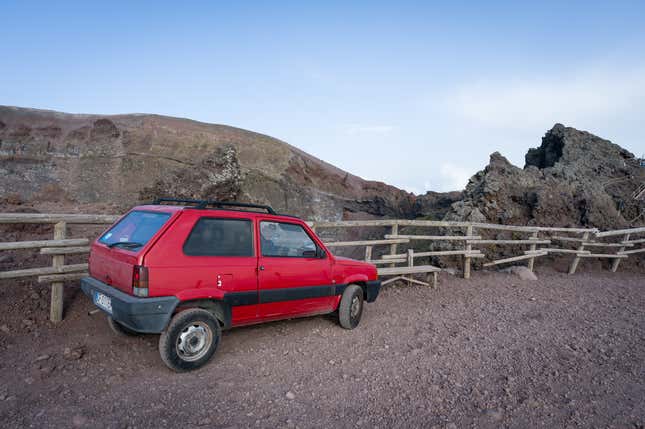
[445,124,645,229]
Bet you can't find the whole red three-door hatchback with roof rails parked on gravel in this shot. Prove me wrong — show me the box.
[81,199,381,371]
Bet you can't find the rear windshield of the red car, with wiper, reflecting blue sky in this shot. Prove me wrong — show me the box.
[99,210,170,250]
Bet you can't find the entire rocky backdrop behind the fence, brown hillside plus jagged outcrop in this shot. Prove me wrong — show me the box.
[0,106,645,229]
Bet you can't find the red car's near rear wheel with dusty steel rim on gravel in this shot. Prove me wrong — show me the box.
[159,308,222,372]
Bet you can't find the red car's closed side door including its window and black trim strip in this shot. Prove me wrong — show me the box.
[257,218,334,320]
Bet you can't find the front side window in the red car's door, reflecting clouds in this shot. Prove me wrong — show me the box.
[260,221,316,258]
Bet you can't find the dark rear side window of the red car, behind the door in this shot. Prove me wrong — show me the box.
[184,217,253,256]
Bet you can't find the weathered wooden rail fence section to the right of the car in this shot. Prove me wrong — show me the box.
[310,219,645,279]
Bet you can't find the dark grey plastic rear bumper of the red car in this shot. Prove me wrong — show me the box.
[81,277,179,334]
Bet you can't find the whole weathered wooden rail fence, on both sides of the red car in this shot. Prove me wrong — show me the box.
[0,213,645,322]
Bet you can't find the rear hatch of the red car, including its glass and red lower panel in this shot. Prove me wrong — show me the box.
[89,209,173,294]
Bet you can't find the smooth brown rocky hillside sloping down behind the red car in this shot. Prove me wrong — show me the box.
[0,106,460,220]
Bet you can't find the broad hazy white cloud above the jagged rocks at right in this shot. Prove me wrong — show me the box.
[443,67,645,129]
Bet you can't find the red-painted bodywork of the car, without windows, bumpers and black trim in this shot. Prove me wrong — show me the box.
[89,205,377,326]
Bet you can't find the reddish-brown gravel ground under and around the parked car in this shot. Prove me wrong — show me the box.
[0,267,645,428]
